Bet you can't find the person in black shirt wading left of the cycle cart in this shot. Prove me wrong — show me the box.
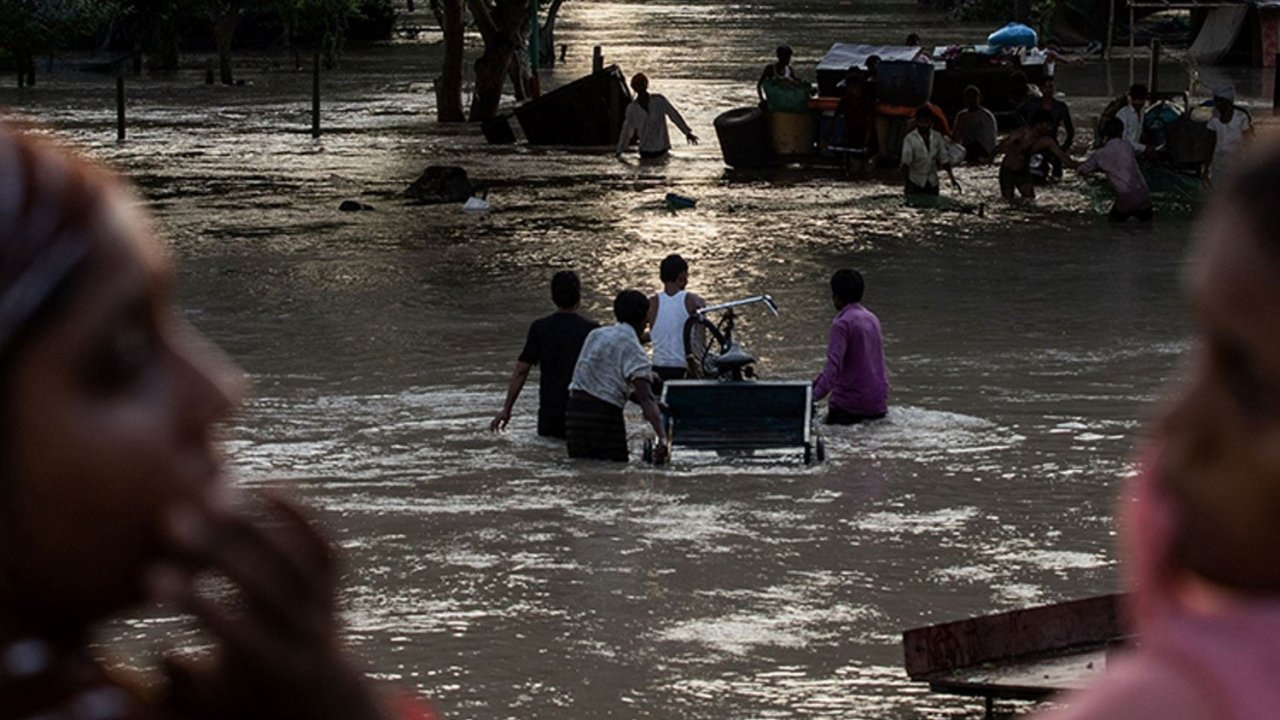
[489,270,599,438]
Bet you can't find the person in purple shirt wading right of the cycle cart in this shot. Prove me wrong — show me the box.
[813,269,888,425]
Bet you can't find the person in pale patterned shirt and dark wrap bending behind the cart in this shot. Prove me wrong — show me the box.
[564,290,667,464]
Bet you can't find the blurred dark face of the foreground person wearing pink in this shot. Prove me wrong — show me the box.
[1161,141,1280,596]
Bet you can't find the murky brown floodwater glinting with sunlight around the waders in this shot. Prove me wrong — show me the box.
[0,0,1263,720]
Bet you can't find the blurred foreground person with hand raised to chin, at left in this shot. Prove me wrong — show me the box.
[0,124,431,720]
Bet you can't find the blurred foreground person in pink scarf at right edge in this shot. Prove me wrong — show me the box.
[1051,137,1280,720]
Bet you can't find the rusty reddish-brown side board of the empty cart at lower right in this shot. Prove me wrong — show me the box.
[902,594,1123,680]
